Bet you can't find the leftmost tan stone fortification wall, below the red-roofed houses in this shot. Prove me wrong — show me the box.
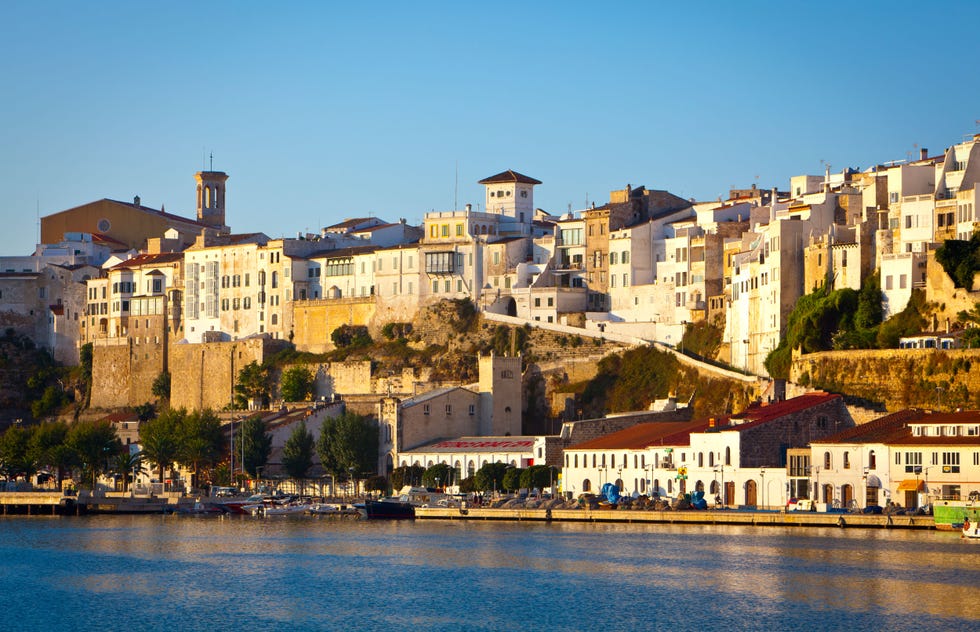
[91,339,167,408]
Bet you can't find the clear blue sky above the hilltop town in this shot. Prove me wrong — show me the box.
[0,0,980,255]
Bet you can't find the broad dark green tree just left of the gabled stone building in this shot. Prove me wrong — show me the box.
[317,411,378,476]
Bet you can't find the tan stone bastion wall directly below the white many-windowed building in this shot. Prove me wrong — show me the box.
[170,337,285,410]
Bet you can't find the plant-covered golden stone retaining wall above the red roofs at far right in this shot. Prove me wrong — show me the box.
[790,349,980,411]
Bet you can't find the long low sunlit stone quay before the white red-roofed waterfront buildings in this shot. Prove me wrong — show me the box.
[415,507,936,529]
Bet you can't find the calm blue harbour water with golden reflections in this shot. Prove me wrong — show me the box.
[0,516,980,632]
